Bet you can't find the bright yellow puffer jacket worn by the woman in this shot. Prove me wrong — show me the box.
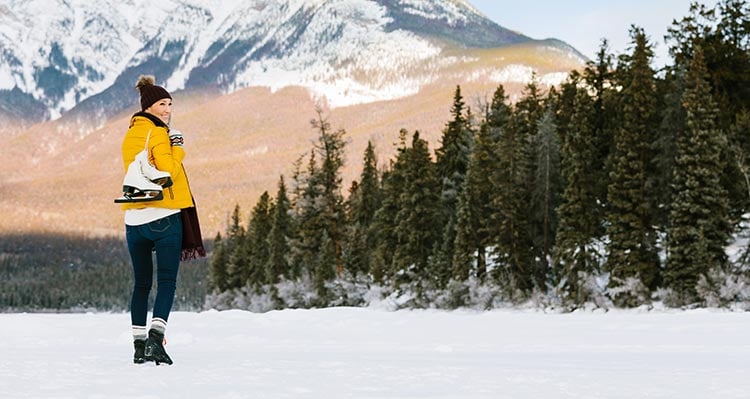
[122,112,193,210]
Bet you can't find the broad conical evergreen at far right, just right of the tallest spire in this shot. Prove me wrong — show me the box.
[665,47,731,304]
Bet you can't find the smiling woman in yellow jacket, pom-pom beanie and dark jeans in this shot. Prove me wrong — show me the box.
[122,76,193,364]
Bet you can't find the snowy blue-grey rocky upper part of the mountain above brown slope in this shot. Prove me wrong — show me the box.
[0,0,581,128]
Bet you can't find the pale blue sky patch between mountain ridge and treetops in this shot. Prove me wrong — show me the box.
[468,0,717,67]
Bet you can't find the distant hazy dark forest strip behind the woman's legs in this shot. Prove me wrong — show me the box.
[0,233,210,312]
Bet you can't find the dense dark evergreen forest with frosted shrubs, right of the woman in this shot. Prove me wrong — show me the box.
[207,0,750,310]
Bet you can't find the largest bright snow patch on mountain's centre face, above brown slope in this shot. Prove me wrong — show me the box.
[230,0,441,108]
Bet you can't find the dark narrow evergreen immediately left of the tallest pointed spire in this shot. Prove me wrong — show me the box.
[555,90,601,304]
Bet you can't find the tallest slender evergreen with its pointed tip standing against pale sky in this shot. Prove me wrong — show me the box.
[607,27,659,306]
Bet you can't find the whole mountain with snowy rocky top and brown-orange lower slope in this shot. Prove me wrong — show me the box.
[0,0,586,237]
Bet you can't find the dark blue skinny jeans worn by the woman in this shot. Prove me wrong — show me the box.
[125,213,182,326]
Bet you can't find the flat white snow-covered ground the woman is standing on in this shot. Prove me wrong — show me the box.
[0,308,750,399]
